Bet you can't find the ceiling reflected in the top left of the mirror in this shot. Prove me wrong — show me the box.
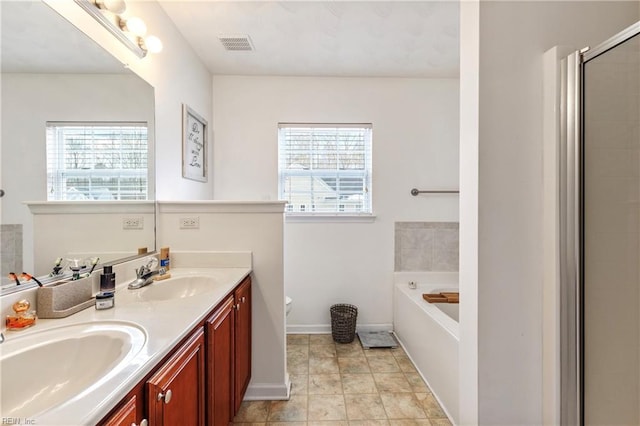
[0,1,129,73]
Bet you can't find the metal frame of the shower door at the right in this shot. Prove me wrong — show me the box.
[559,22,640,425]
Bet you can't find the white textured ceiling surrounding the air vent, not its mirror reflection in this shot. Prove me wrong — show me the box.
[159,0,459,78]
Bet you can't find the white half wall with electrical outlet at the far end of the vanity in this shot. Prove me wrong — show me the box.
[158,201,289,400]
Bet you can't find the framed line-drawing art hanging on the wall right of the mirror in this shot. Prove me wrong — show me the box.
[182,104,209,182]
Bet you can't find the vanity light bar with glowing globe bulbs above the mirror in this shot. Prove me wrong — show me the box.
[74,0,162,58]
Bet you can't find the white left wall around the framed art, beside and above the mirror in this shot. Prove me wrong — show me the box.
[44,0,213,200]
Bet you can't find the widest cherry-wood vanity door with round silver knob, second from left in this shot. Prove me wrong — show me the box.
[147,327,205,426]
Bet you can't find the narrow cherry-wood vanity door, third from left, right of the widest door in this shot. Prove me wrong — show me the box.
[206,296,235,426]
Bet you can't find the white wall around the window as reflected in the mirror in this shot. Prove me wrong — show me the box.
[2,74,154,275]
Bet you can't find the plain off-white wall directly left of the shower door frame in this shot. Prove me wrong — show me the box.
[460,2,638,424]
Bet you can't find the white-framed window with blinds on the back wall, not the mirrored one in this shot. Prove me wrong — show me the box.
[278,123,375,222]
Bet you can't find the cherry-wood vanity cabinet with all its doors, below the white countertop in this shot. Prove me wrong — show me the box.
[99,277,251,426]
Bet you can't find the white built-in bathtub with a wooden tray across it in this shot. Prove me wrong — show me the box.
[393,273,459,424]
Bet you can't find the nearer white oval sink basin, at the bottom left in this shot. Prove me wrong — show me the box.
[0,321,147,418]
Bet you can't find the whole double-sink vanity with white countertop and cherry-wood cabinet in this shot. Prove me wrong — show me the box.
[0,267,251,426]
